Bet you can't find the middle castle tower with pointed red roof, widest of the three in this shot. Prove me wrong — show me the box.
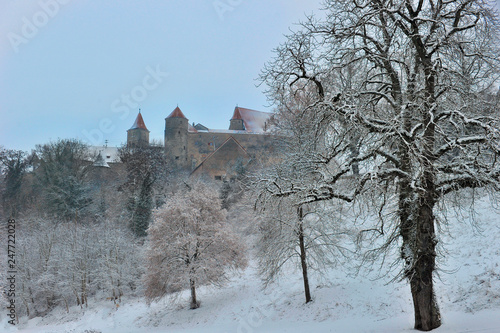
[165,107,189,168]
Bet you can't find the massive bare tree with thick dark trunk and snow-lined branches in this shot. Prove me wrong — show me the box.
[262,0,500,331]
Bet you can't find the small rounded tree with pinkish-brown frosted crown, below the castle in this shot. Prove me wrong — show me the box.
[145,182,246,309]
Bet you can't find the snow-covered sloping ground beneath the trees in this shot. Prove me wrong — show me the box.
[0,196,500,333]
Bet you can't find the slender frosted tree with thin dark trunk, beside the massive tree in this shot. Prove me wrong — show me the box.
[251,86,350,303]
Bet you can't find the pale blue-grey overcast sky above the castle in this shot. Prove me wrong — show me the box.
[0,0,320,151]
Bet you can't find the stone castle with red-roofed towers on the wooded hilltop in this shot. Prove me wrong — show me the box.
[127,106,274,180]
